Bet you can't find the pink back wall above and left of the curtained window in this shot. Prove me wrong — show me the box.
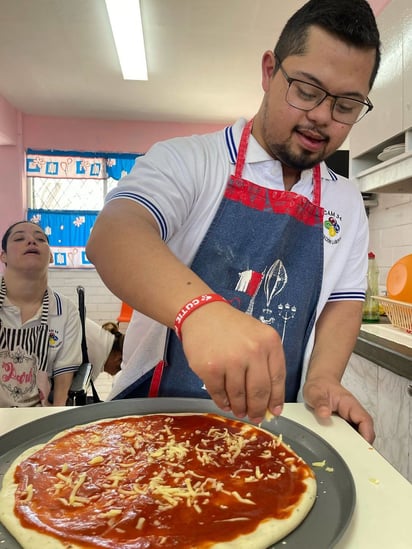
[0,112,229,237]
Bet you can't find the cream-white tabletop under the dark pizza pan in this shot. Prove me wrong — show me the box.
[0,404,412,549]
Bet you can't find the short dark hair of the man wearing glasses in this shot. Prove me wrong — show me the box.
[274,0,381,88]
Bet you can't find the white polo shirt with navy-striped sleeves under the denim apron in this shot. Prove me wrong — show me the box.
[106,119,368,397]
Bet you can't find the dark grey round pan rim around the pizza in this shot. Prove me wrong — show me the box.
[0,398,356,549]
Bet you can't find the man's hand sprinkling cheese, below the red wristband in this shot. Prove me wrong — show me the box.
[181,302,286,423]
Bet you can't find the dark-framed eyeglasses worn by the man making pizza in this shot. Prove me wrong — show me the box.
[277,59,373,125]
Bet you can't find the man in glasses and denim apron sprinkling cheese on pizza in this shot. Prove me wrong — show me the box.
[87,0,380,441]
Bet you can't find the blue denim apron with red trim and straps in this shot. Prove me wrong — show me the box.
[119,120,323,402]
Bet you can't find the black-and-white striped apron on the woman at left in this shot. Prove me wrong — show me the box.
[0,279,50,406]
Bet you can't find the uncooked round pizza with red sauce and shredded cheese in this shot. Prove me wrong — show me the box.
[0,414,316,549]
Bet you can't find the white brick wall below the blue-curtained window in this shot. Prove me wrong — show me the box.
[49,268,121,324]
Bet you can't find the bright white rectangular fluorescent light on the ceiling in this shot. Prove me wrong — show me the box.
[106,0,147,80]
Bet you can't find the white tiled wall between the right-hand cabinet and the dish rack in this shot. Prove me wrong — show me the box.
[369,193,412,293]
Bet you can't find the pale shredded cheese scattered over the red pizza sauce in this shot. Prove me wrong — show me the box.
[12,415,316,546]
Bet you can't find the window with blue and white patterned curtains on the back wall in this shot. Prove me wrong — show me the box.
[26,150,139,268]
